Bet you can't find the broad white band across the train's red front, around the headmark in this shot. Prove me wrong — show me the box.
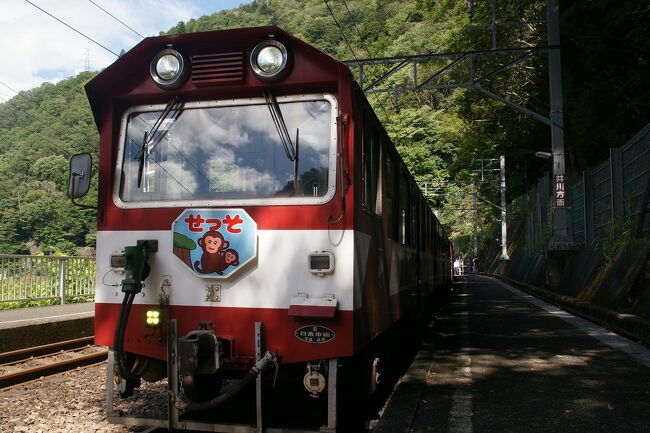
[95,230,360,311]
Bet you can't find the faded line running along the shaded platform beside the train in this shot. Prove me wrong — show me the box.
[449,283,474,433]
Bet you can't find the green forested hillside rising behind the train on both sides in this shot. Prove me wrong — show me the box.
[0,0,650,253]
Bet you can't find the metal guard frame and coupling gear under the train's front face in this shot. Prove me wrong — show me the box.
[106,319,339,433]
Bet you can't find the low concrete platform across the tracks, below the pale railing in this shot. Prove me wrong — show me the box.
[0,302,95,352]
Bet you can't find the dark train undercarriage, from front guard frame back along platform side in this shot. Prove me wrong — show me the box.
[106,308,428,433]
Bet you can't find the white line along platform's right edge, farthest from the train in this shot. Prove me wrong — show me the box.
[499,282,650,367]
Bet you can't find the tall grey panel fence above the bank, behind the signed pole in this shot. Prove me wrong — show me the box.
[523,124,650,254]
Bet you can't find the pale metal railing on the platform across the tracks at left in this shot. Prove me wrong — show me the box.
[0,254,95,304]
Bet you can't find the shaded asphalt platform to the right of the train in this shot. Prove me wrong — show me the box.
[373,276,650,433]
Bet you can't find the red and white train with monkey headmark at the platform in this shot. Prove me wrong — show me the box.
[68,27,451,431]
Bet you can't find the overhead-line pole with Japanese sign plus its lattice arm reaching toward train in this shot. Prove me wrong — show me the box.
[345,0,573,251]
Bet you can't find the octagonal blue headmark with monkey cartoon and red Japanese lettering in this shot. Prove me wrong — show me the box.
[172,209,257,278]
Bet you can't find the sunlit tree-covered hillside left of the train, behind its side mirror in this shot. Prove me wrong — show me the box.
[0,73,99,254]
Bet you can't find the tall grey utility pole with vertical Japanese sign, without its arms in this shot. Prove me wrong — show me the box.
[546,0,573,250]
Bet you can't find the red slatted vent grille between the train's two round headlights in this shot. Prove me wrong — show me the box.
[192,52,244,86]
